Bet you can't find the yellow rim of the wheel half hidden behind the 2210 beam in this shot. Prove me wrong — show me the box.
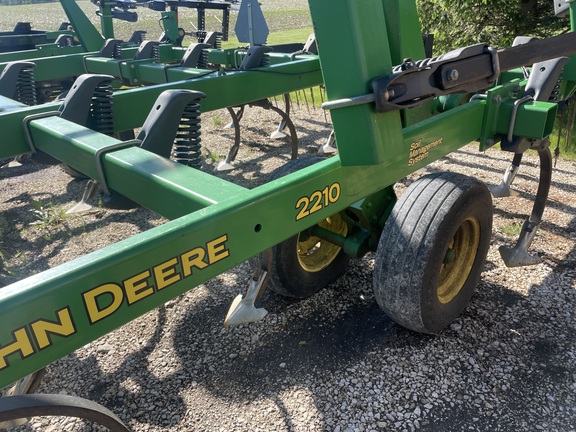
[296,214,348,273]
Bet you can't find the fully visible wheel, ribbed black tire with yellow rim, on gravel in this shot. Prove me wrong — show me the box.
[374,173,493,334]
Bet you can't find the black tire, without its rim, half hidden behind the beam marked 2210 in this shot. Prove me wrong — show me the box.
[250,157,349,298]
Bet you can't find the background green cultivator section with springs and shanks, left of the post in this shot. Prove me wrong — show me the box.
[0,0,304,165]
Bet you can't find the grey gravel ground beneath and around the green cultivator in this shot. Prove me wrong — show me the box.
[0,98,576,432]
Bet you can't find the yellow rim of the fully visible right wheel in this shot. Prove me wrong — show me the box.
[437,217,480,304]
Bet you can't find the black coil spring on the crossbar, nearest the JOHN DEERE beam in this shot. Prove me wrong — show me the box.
[172,100,201,168]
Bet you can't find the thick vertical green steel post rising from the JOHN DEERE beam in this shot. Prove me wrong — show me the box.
[309,0,406,166]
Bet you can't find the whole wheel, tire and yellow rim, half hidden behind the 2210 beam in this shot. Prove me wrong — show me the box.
[250,157,349,298]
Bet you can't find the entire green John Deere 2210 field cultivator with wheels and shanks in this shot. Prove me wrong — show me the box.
[0,0,576,431]
